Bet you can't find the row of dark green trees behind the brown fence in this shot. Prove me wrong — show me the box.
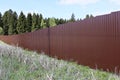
[0,9,94,35]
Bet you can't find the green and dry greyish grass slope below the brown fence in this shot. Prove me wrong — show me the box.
[0,42,120,80]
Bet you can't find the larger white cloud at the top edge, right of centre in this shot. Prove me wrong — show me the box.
[59,0,99,5]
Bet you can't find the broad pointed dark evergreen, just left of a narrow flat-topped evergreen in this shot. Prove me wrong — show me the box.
[17,12,26,33]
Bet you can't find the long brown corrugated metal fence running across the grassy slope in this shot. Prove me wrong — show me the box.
[0,12,120,71]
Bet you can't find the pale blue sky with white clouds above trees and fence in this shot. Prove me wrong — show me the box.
[0,0,120,19]
